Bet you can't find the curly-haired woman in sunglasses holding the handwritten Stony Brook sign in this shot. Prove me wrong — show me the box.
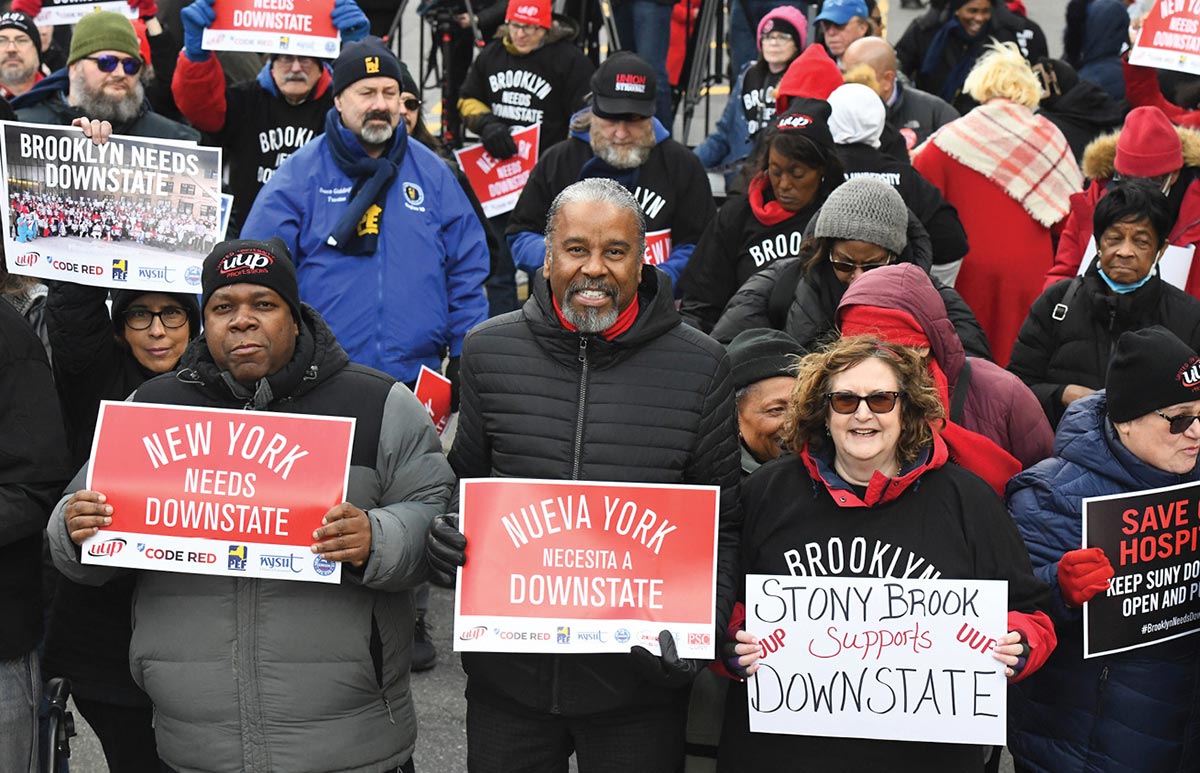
[718,336,1055,773]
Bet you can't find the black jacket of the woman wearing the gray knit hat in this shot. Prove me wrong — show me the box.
[712,210,991,360]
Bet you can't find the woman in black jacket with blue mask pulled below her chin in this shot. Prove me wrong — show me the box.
[1008,179,1200,426]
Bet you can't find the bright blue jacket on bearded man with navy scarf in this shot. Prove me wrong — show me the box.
[241,117,488,384]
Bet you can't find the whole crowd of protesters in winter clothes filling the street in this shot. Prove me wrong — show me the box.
[11,0,1200,773]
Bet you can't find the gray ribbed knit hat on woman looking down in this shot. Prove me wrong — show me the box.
[814,178,908,254]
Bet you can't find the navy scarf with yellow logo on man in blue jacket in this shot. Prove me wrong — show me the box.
[325,108,408,254]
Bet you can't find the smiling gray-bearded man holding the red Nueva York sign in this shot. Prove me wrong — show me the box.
[430,178,740,773]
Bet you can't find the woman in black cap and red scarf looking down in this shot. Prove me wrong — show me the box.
[679,100,842,338]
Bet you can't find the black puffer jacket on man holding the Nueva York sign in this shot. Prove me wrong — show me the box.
[450,266,742,715]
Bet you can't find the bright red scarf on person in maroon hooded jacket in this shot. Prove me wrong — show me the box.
[841,306,1021,496]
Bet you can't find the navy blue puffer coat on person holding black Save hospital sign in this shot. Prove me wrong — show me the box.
[1007,391,1200,773]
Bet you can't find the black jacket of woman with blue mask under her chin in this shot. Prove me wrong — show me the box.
[1008,258,1200,427]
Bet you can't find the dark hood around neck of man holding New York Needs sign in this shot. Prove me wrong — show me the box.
[175,304,350,411]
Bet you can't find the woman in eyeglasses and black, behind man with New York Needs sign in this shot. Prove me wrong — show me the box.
[43,282,200,773]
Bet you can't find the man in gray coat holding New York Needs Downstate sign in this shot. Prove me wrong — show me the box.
[48,239,454,772]
